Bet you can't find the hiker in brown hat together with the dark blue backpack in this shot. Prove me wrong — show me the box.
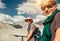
[25,18,40,41]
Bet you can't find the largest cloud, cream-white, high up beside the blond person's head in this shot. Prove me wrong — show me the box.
[16,1,42,14]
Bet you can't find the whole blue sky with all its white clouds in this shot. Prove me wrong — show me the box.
[0,0,60,24]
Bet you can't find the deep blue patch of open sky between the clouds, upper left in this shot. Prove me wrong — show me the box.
[1,0,25,16]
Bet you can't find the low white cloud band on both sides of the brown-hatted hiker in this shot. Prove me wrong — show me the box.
[0,13,47,24]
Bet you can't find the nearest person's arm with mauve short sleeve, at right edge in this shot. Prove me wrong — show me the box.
[54,12,60,41]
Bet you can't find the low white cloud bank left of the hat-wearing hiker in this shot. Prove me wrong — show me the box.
[0,13,25,24]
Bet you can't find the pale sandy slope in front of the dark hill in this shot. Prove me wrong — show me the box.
[0,22,27,41]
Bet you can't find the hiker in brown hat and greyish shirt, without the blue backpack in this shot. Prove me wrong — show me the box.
[25,18,36,41]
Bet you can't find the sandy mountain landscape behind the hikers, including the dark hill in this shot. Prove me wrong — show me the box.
[0,22,43,41]
